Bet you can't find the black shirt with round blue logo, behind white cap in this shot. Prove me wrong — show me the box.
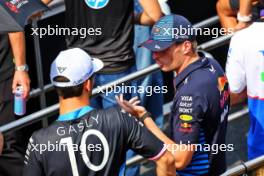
[65,0,135,73]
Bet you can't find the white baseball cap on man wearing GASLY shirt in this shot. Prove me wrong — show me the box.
[50,48,104,87]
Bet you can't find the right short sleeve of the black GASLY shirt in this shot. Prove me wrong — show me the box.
[122,113,166,160]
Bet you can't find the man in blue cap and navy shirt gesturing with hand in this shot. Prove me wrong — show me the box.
[117,15,233,175]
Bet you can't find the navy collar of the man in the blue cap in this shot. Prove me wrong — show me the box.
[174,57,209,88]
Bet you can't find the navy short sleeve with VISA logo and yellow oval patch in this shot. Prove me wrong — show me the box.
[171,93,208,144]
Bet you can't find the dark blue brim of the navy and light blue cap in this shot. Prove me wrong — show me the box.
[139,39,175,52]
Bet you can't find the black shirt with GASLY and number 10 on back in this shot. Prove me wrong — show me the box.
[24,106,164,176]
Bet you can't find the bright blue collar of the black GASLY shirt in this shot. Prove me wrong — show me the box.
[57,106,93,121]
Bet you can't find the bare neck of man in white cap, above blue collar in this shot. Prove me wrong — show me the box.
[60,96,90,115]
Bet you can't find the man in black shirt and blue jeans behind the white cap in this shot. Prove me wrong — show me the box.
[42,0,162,108]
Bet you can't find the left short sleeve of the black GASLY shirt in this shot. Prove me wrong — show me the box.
[23,134,44,176]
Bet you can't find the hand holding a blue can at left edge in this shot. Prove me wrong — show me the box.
[12,71,30,98]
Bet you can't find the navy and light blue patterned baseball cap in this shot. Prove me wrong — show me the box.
[140,14,196,52]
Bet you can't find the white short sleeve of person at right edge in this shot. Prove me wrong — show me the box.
[226,36,246,93]
